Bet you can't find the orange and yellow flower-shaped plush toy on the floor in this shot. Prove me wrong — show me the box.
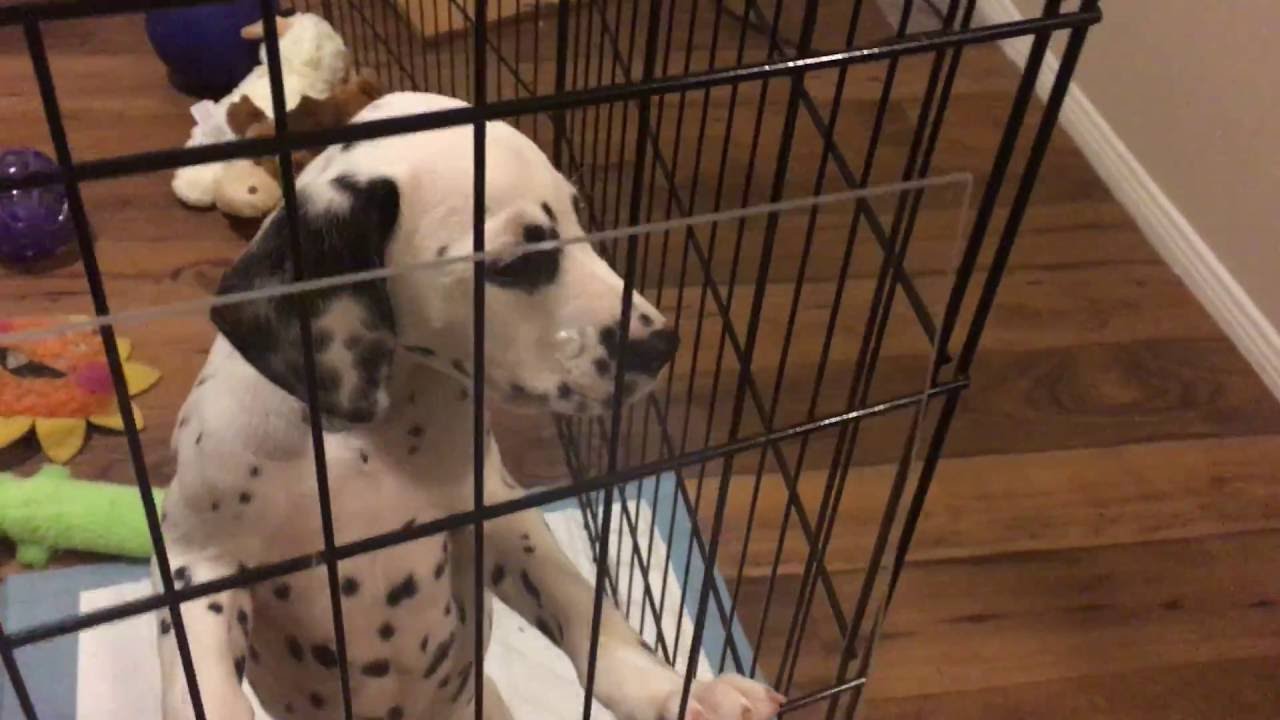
[0,316,160,462]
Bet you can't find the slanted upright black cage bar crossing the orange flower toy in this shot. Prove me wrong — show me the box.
[21,20,205,720]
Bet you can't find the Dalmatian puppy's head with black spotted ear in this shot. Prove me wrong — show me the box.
[212,133,678,421]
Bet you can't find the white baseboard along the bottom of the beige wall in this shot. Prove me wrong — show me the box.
[974,0,1280,397]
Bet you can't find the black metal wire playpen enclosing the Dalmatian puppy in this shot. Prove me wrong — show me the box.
[0,0,1101,720]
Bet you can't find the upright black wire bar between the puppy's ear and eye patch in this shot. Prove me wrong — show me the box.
[471,0,486,720]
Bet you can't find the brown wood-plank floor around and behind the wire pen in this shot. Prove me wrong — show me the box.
[0,3,1280,720]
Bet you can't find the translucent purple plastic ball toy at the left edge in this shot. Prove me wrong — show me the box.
[0,147,74,264]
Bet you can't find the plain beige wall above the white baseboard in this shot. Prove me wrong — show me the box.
[1015,0,1280,328]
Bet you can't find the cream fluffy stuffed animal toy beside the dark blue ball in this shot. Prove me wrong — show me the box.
[172,13,351,218]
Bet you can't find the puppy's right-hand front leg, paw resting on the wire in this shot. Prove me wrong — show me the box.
[484,497,783,720]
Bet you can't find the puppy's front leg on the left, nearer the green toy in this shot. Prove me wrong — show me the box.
[151,544,253,720]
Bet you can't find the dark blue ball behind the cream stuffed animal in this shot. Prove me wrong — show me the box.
[146,0,276,97]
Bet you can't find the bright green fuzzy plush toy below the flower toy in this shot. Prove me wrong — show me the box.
[0,465,164,568]
